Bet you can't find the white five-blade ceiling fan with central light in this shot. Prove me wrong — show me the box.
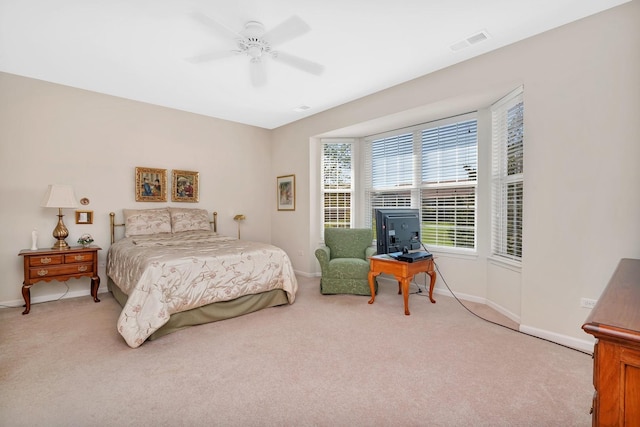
[188,13,324,87]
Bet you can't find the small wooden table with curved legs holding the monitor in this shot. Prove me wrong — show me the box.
[369,255,436,316]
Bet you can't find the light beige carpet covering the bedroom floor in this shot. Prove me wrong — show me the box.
[0,277,593,426]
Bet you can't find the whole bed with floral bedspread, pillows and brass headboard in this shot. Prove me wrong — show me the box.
[107,207,298,348]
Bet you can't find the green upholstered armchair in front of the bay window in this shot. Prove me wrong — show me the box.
[316,228,378,295]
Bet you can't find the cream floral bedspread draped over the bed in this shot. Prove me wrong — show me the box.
[107,231,298,348]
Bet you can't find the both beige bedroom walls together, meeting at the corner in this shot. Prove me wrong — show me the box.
[0,0,640,352]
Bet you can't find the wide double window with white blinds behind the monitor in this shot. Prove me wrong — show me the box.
[365,114,478,249]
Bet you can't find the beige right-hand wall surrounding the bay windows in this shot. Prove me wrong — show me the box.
[272,1,640,347]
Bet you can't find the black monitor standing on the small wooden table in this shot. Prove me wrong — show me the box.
[375,208,422,254]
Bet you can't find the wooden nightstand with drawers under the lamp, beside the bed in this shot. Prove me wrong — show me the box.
[18,246,102,314]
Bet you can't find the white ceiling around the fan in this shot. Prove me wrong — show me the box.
[0,0,628,129]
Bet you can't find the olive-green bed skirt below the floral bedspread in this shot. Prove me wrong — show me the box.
[107,277,289,341]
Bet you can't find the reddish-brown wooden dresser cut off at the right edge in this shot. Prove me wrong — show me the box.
[582,259,640,426]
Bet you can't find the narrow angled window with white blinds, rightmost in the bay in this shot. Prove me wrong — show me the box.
[491,87,524,262]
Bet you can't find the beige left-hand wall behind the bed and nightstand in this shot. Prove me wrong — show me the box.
[0,73,275,310]
